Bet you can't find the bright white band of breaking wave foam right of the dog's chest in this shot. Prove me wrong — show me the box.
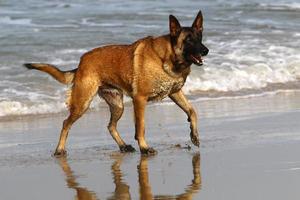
[184,60,300,94]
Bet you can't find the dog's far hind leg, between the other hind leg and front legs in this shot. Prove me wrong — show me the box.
[98,88,135,152]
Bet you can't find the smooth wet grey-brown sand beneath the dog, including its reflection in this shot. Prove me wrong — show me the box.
[0,92,300,200]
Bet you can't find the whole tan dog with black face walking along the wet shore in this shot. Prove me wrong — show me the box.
[24,11,208,156]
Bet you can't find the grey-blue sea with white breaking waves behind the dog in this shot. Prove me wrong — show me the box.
[0,0,300,118]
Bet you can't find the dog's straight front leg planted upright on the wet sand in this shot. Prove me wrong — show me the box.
[133,96,156,155]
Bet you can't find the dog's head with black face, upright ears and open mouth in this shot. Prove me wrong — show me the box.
[169,11,209,66]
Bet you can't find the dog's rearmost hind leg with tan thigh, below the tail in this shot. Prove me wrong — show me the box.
[54,76,99,156]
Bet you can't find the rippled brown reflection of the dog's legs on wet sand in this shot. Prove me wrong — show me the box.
[58,154,201,200]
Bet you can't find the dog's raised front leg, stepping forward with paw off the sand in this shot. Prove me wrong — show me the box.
[169,90,200,147]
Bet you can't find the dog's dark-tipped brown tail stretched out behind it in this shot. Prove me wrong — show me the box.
[24,63,77,85]
